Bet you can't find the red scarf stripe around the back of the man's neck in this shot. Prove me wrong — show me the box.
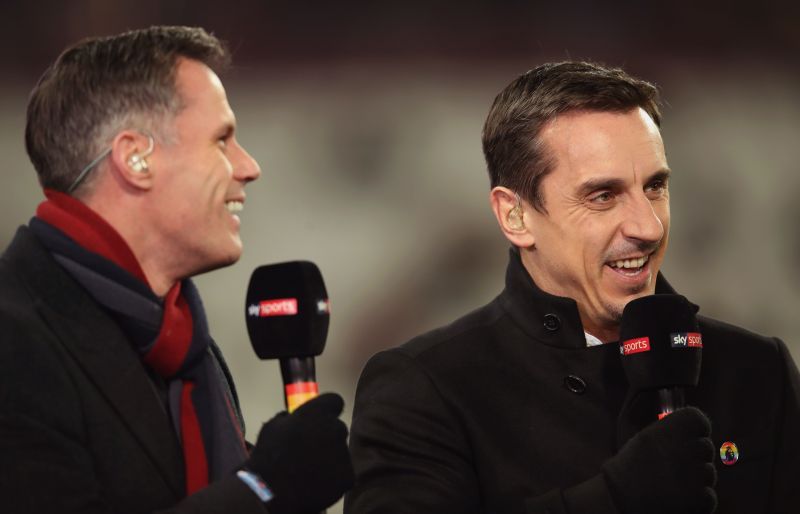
[36,189,150,287]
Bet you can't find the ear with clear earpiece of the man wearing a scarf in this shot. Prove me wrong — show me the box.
[111,130,153,190]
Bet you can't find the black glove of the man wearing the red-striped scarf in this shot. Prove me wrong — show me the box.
[245,393,354,514]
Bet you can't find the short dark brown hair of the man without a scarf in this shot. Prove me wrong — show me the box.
[483,62,661,212]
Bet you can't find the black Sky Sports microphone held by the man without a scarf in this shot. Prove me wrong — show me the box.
[619,294,703,419]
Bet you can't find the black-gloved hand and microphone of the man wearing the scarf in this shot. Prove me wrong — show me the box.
[245,261,355,514]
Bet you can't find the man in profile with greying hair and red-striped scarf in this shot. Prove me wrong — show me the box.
[0,27,353,514]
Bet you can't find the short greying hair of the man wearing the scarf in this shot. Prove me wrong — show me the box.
[25,27,230,192]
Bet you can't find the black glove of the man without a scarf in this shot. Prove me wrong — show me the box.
[603,407,717,514]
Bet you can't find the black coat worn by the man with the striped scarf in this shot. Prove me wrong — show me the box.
[0,227,266,514]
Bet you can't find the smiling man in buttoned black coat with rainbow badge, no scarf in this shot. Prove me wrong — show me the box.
[345,62,800,514]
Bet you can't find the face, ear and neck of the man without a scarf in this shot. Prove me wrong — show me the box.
[510,107,669,341]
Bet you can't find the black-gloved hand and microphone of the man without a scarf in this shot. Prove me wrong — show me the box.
[603,295,717,514]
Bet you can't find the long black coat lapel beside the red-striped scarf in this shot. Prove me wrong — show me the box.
[4,227,184,498]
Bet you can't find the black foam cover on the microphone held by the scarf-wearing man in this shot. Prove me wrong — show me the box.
[245,261,330,359]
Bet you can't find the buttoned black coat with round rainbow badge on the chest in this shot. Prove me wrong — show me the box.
[345,248,800,514]
